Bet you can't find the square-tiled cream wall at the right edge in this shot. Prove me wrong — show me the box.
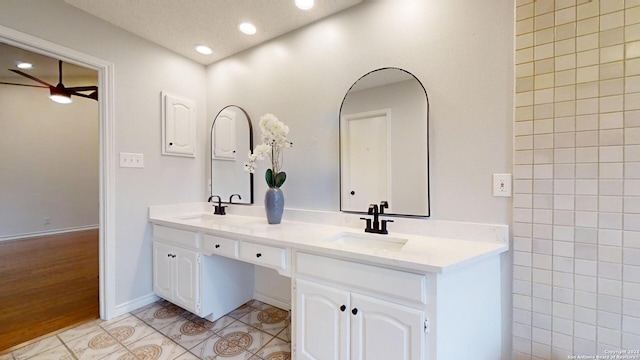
[513,0,640,359]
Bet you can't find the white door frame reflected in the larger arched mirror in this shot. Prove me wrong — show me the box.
[340,109,393,212]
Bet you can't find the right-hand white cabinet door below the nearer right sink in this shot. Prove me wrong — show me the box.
[351,294,424,360]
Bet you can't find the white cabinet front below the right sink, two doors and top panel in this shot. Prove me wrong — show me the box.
[294,253,428,360]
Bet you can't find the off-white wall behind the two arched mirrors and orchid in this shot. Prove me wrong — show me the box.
[207,0,513,224]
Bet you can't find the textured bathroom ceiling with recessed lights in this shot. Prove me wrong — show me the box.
[65,0,364,65]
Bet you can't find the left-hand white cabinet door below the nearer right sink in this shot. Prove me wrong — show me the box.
[295,279,349,360]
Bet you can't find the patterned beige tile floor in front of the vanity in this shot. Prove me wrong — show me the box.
[0,300,291,360]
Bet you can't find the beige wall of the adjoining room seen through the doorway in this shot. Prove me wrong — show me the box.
[0,79,99,239]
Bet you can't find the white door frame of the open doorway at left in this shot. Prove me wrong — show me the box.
[0,25,116,320]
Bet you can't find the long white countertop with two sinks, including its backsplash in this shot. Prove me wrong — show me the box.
[149,203,509,273]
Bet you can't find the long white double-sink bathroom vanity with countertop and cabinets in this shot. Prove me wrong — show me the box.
[149,203,508,360]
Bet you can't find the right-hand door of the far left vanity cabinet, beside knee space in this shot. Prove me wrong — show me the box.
[172,248,200,314]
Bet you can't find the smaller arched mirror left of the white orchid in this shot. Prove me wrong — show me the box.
[211,105,253,204]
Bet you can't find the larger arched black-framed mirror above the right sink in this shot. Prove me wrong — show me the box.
[340,68,430,217]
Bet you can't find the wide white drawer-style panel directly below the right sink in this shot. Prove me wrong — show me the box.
[296,253,427,304]
